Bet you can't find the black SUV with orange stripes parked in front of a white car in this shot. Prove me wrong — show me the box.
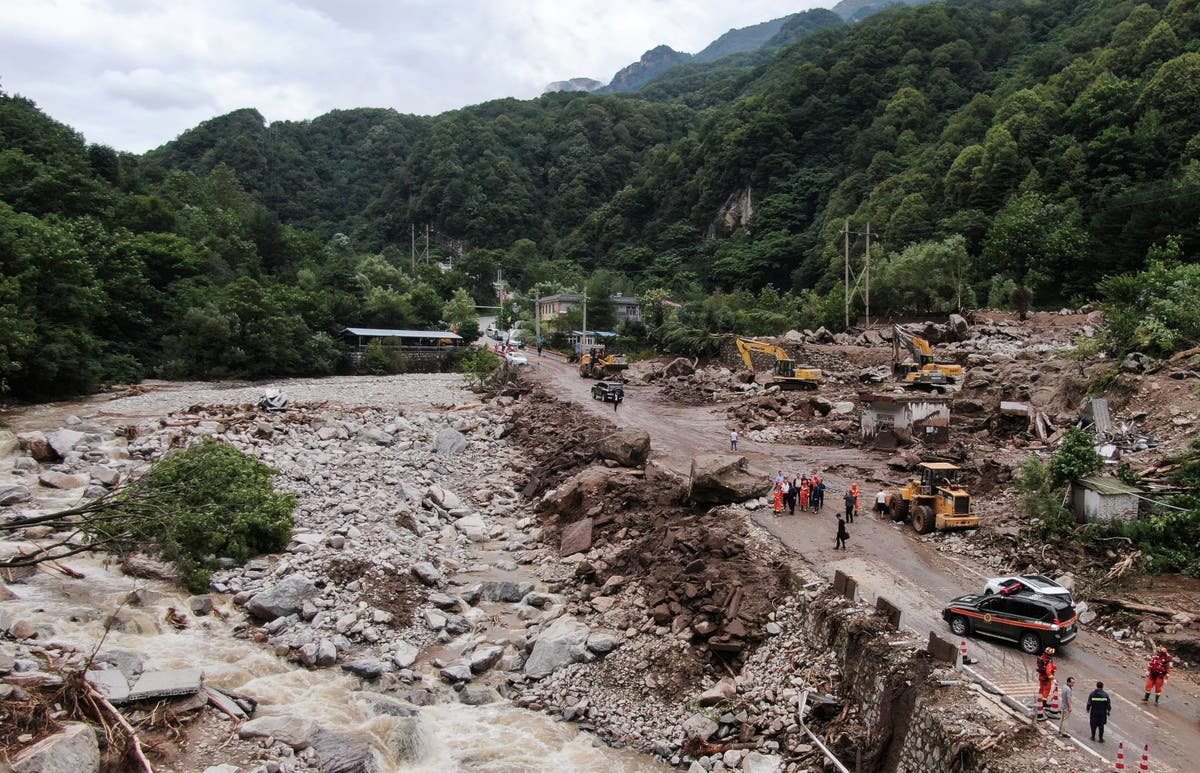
[942,592,1079,654]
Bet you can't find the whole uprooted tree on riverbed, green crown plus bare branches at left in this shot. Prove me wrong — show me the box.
[0,438,296,593]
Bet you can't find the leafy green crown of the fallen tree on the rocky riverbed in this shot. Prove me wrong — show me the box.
[101,438,296,593]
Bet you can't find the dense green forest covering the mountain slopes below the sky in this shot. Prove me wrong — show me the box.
[0,0,1200,399]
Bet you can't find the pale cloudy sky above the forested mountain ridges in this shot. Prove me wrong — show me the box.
[0,0,835,152]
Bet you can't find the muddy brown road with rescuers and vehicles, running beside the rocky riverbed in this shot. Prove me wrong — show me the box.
[529,355,1200,772]
